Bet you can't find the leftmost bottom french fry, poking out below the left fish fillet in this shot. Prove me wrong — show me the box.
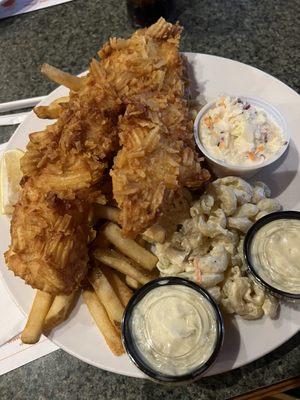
[21,290,53,344]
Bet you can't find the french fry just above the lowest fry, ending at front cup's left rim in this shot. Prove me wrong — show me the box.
[88,266,124,331]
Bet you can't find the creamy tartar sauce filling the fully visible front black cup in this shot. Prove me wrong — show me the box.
[131,285,217,376]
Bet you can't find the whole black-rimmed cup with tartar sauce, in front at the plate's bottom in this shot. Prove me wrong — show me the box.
[122,277,224,384]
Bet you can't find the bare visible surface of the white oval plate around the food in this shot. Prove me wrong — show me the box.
[0,53,300,378]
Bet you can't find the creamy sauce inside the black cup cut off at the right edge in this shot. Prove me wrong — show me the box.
[250,219,300,294]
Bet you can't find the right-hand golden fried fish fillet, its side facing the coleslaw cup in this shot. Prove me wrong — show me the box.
[109,19,209,237]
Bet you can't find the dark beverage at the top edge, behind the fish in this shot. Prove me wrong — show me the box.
[127,0,173,28]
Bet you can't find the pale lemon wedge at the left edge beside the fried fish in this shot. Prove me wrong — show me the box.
[0,149,24,215]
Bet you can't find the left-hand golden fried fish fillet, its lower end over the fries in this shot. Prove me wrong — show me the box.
[5,58,121,294]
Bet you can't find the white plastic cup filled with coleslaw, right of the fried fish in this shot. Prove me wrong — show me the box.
[194,96,290,178]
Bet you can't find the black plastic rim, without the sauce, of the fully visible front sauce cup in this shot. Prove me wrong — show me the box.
[122,277,224,384]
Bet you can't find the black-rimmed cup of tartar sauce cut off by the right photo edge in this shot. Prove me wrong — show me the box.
[244,211,300,301]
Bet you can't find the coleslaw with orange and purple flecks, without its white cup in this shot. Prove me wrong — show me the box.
[200,96,287,166]
